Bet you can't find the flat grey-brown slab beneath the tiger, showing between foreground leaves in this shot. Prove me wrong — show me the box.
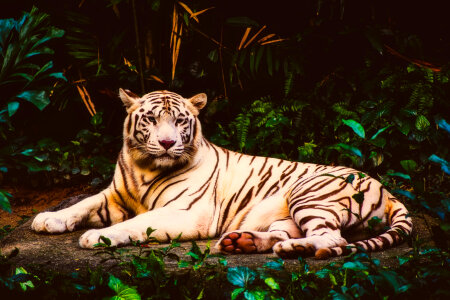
[0,195,436,273]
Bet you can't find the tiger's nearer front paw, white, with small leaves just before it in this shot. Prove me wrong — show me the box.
[79,227,147,249]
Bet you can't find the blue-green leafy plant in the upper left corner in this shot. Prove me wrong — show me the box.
[0,7,67,129]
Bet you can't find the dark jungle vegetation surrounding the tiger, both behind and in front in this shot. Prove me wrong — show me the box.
[0,0,450,299]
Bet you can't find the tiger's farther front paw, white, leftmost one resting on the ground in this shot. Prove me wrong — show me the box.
[31,211,83,233]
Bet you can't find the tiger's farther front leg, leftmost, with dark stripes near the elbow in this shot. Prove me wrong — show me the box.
[31,188,133,233]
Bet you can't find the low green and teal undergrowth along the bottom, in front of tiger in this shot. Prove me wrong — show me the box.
[0,228,450,299]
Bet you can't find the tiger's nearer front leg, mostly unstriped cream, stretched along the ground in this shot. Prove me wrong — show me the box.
[79,207,210,248]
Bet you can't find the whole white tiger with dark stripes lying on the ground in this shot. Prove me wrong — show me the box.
[31,89,413,259]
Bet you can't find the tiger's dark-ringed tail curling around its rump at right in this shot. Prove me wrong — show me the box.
[315,197,413,259]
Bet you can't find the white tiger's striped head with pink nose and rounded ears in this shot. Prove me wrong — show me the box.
[119,89,206,168]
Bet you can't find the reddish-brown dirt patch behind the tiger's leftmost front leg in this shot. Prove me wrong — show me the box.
[0,184,96,228]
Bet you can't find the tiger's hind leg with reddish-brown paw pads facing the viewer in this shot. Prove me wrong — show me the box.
[216,217,300,254]
